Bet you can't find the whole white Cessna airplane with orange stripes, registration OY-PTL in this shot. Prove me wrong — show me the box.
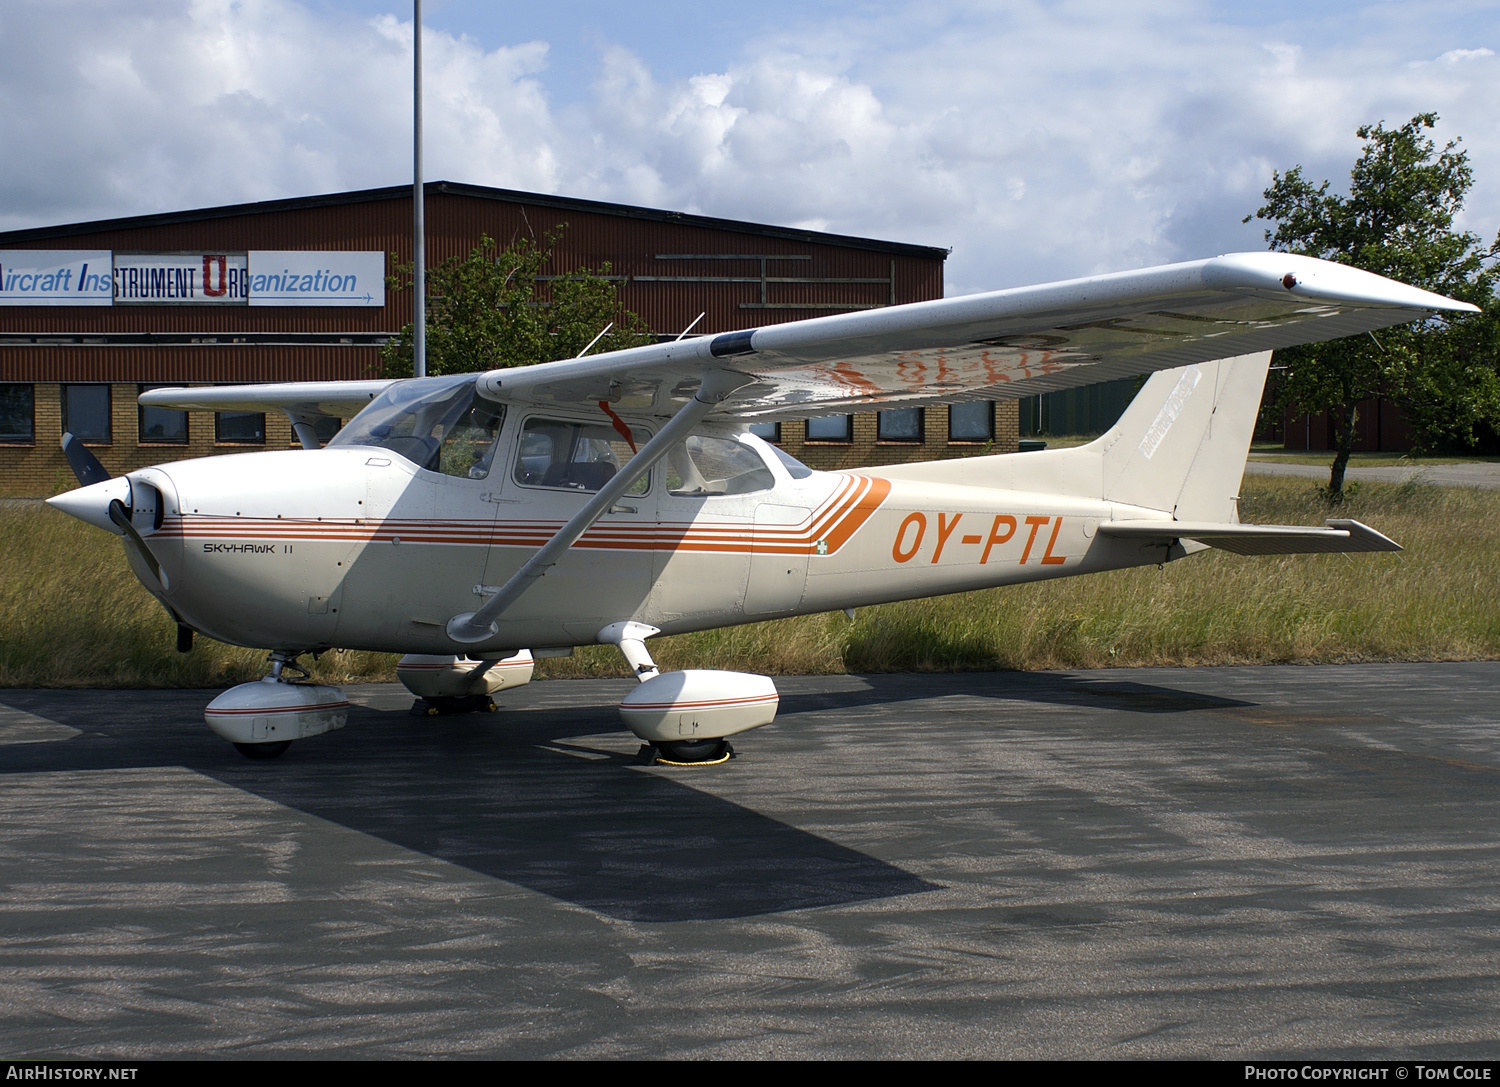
[50,253,1475,762]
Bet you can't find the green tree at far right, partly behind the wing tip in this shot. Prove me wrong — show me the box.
[1245,114,1500,504]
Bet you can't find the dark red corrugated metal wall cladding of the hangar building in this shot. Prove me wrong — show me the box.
[0,192,942,381]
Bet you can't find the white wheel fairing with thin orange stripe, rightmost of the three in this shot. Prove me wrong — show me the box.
[620,669,780,744]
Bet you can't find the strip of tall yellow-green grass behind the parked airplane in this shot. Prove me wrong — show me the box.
[0,477,1500,687]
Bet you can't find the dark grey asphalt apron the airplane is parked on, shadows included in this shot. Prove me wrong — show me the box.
[0,663,1500,1059]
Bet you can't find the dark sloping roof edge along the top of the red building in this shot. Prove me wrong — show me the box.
[0,181,950,261]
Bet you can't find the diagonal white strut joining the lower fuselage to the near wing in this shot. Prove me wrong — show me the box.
[447,369,755,645]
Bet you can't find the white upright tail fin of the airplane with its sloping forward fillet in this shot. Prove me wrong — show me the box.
[864,351,1271,523]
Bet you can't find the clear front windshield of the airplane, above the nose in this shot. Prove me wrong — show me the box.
[329,375,506,480]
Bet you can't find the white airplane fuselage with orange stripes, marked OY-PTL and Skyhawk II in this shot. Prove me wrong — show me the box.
[93,411,1169,654]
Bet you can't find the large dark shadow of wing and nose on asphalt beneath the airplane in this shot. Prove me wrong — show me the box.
[0,691,938,922]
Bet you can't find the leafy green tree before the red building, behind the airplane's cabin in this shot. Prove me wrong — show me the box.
[381,228,654,378]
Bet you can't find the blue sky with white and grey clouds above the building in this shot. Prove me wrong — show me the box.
[0,0,1500,294]
